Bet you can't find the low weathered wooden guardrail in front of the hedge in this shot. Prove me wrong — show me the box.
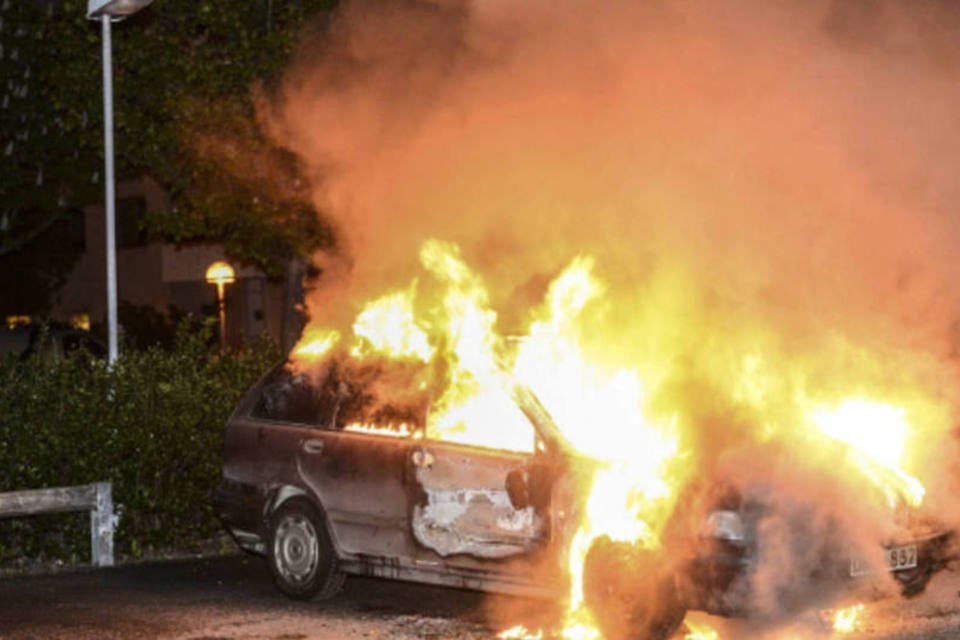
[0,482,120,567]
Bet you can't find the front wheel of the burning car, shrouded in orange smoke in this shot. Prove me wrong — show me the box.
[583,536,686,640]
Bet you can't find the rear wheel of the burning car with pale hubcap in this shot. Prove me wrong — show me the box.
[267,498,346,600]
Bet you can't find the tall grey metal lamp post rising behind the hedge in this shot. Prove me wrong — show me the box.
[87,0,152,365]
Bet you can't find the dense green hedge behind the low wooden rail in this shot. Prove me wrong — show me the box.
[0,325,280,565]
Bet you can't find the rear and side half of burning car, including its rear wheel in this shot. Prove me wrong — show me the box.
[216,366,575,598]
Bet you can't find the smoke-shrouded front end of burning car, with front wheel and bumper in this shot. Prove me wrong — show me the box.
[583,482,957,638]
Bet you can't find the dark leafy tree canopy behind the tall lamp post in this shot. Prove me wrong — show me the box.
[0,0,333,316]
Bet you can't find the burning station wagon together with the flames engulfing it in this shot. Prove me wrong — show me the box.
[210,241,953,640]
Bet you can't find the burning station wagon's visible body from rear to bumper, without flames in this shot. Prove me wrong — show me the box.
[215,365,952,640]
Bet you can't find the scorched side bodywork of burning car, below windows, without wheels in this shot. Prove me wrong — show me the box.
[216,368,562,592]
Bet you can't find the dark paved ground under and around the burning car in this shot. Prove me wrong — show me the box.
[0,556,960,640]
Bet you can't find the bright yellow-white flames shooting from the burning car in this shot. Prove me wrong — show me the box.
[292,240,939,639]
